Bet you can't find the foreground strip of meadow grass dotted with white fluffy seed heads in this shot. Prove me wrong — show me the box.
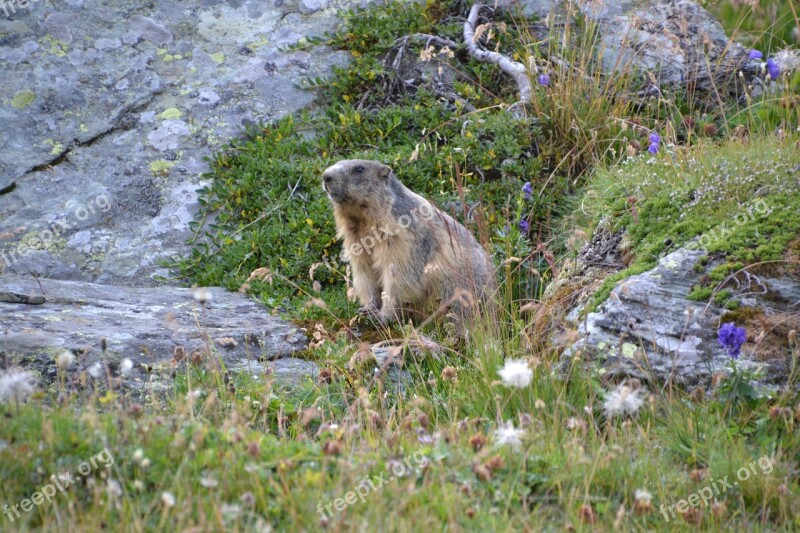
[0,339,800,531]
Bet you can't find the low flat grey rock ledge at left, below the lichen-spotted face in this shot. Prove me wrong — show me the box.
[0,275,317,386]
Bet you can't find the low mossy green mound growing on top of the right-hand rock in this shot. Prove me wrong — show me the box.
[573,135,800,311]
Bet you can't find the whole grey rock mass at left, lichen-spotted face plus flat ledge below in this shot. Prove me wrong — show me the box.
[0,0,382,381]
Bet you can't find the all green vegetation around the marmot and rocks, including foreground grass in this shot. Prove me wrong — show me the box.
[0,2,800,531]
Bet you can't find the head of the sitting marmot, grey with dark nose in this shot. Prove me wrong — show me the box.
[322,159,392,207]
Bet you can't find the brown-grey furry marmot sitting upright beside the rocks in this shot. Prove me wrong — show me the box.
[322,160,497,321]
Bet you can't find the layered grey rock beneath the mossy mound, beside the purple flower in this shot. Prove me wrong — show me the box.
[565,249,800,385]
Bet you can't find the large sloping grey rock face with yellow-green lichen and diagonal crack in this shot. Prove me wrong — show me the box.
[0,0,376,286]
